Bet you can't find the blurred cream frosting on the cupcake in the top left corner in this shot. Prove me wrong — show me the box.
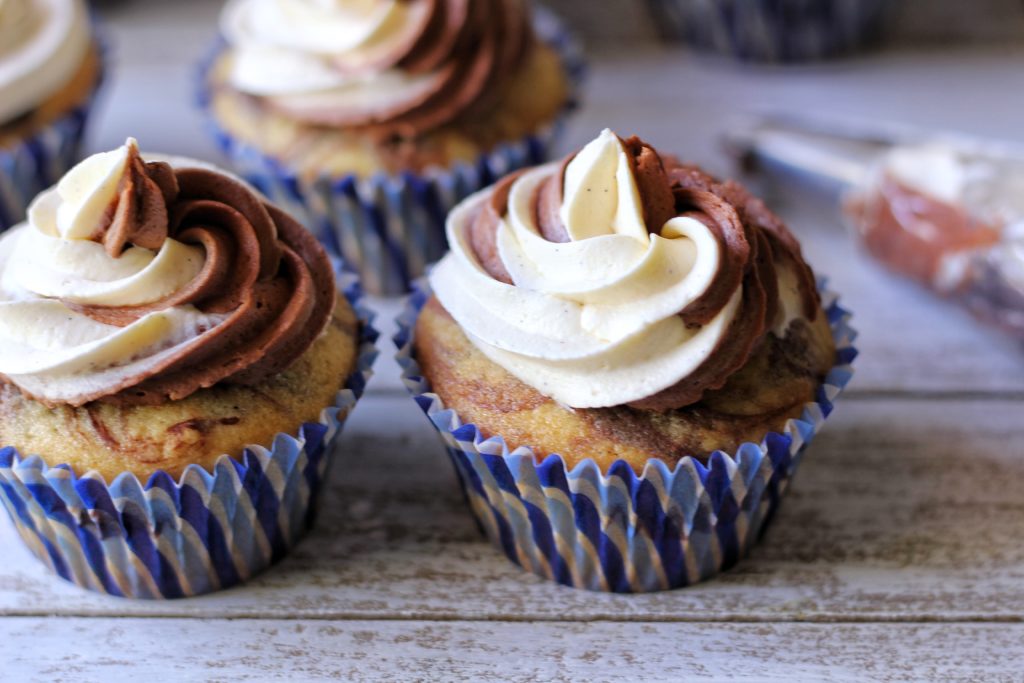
[0,0,91,124]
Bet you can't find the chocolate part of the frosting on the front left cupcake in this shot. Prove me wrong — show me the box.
[65,148,336,404]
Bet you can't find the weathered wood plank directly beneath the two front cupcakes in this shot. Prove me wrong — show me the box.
[0,397,1024,621]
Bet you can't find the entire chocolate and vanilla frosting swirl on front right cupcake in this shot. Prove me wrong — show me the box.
[431,130,819,411]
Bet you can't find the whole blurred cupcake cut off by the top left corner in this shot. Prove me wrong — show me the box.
[0,0,102,230]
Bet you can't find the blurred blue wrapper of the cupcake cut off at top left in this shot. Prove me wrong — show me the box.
[0,28,109,231]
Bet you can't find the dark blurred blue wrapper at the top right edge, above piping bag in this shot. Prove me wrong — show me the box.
[648,0,886,61]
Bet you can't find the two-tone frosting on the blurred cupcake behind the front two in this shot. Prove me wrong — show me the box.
[221,0,531,136]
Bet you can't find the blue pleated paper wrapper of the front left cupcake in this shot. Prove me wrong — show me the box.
[0,273,377,598]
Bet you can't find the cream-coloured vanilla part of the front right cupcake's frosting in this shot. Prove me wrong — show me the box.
[430,130,800,408]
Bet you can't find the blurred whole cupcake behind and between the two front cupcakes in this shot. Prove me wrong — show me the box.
[202,0,581,294]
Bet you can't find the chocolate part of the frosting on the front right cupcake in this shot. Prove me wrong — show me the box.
[460,137,820,412]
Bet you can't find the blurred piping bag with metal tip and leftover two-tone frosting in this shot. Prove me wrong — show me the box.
[724,114,1024,340]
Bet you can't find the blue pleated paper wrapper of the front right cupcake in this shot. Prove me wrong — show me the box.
[394,283,857,593]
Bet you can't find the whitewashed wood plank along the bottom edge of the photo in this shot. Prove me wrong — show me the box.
[0,618,1024,682]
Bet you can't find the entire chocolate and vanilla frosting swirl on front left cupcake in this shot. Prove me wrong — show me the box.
[0,139,336,405]
